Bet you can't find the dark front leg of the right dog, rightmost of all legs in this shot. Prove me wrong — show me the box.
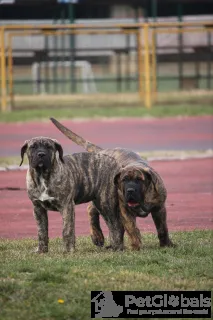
[151,206,175,247]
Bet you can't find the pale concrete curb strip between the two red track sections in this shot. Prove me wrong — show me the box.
[0,154,213,172]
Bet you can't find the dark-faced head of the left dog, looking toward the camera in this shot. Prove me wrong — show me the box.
[20,137,64,171]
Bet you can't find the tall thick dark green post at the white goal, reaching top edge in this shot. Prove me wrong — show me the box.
[69,2,76,92]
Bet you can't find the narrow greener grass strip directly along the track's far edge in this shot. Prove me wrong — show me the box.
[0,104,213,122]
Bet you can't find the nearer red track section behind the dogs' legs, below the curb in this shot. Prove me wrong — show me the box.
[0,158,213,238]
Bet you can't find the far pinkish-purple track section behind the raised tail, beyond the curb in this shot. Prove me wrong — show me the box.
[0,114,213,157]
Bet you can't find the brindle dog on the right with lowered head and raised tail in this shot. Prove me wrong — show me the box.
[51,118,173,250]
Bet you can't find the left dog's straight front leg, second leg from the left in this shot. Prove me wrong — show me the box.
[62,201,75,252]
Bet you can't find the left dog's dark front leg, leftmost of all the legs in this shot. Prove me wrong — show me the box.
[33,205,49,253]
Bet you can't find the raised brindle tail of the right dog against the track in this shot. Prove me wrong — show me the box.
[50,118,103,152]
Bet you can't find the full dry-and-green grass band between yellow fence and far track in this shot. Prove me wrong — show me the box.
[0,90,213,122]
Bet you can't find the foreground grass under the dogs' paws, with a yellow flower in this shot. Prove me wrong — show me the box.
[0,231,213,320]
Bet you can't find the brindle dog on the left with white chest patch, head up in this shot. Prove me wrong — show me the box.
[20,137,124,253]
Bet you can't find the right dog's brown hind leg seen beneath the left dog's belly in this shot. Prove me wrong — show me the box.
[87,202,104,247]
